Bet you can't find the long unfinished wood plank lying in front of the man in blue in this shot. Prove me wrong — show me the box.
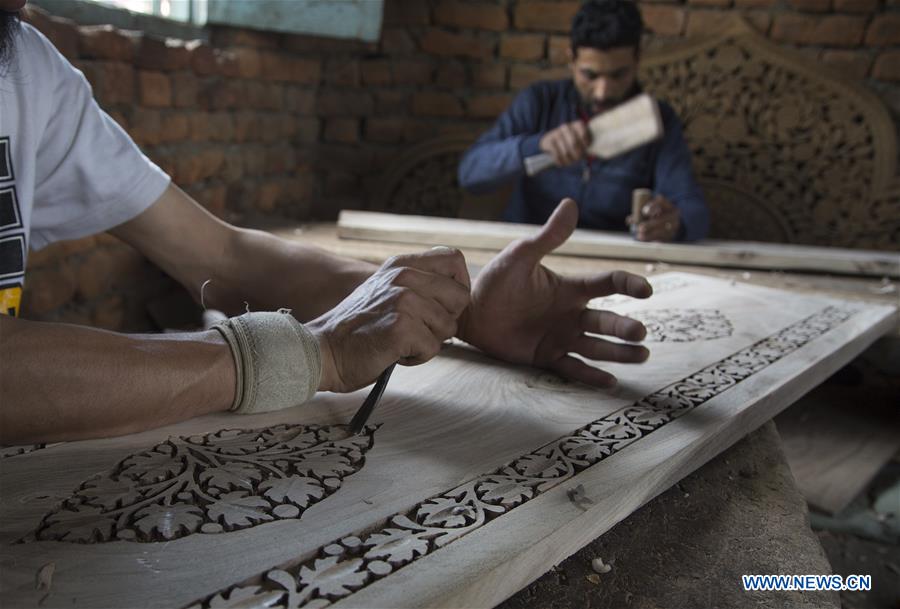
[338,210,900,277]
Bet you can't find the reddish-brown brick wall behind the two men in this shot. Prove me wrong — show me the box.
[17,0,900,329]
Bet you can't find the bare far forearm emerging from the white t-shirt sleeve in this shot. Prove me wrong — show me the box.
[111,185,376,321]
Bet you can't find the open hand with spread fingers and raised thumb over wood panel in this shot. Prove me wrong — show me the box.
[457,199,653,387]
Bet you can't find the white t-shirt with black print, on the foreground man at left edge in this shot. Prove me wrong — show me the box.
[0,23,169,314]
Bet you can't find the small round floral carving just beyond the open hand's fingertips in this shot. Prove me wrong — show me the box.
[628,309,734,343]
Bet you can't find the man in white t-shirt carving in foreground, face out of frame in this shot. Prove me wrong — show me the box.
[0,0,651,444]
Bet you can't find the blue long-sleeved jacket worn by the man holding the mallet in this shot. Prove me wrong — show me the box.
[459,79,709,241]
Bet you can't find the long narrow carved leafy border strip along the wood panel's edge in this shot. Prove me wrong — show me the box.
[191,306,855,609]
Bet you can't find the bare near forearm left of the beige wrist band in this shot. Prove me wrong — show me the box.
[0,315,235,444]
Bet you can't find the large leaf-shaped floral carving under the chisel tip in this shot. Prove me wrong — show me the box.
[27,425,375,540]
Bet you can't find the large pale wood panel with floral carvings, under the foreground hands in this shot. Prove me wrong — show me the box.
[0,274,896,607]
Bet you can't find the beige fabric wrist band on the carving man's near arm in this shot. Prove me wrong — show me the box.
[214,309,322,414]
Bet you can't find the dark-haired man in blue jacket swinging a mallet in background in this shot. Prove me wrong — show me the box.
[459,0,709,241]
